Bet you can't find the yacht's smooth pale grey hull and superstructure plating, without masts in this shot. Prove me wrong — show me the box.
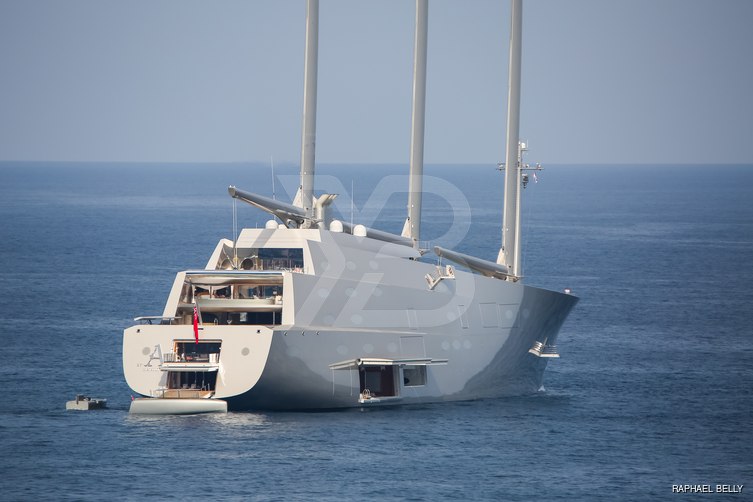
[123,229,577,410]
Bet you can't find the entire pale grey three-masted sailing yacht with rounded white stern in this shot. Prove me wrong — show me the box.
[123,0,577,413]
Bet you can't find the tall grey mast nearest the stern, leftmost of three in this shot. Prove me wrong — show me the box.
[299,0,319,225]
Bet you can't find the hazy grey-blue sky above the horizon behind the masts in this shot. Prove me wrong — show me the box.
[0,0,753,164]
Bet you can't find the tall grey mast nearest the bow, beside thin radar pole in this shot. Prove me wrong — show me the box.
[497,0,523,280]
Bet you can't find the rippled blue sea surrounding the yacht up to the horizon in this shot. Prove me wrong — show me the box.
[0,162,753,501]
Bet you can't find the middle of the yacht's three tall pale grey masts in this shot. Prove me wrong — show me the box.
[402,0,429,249]
